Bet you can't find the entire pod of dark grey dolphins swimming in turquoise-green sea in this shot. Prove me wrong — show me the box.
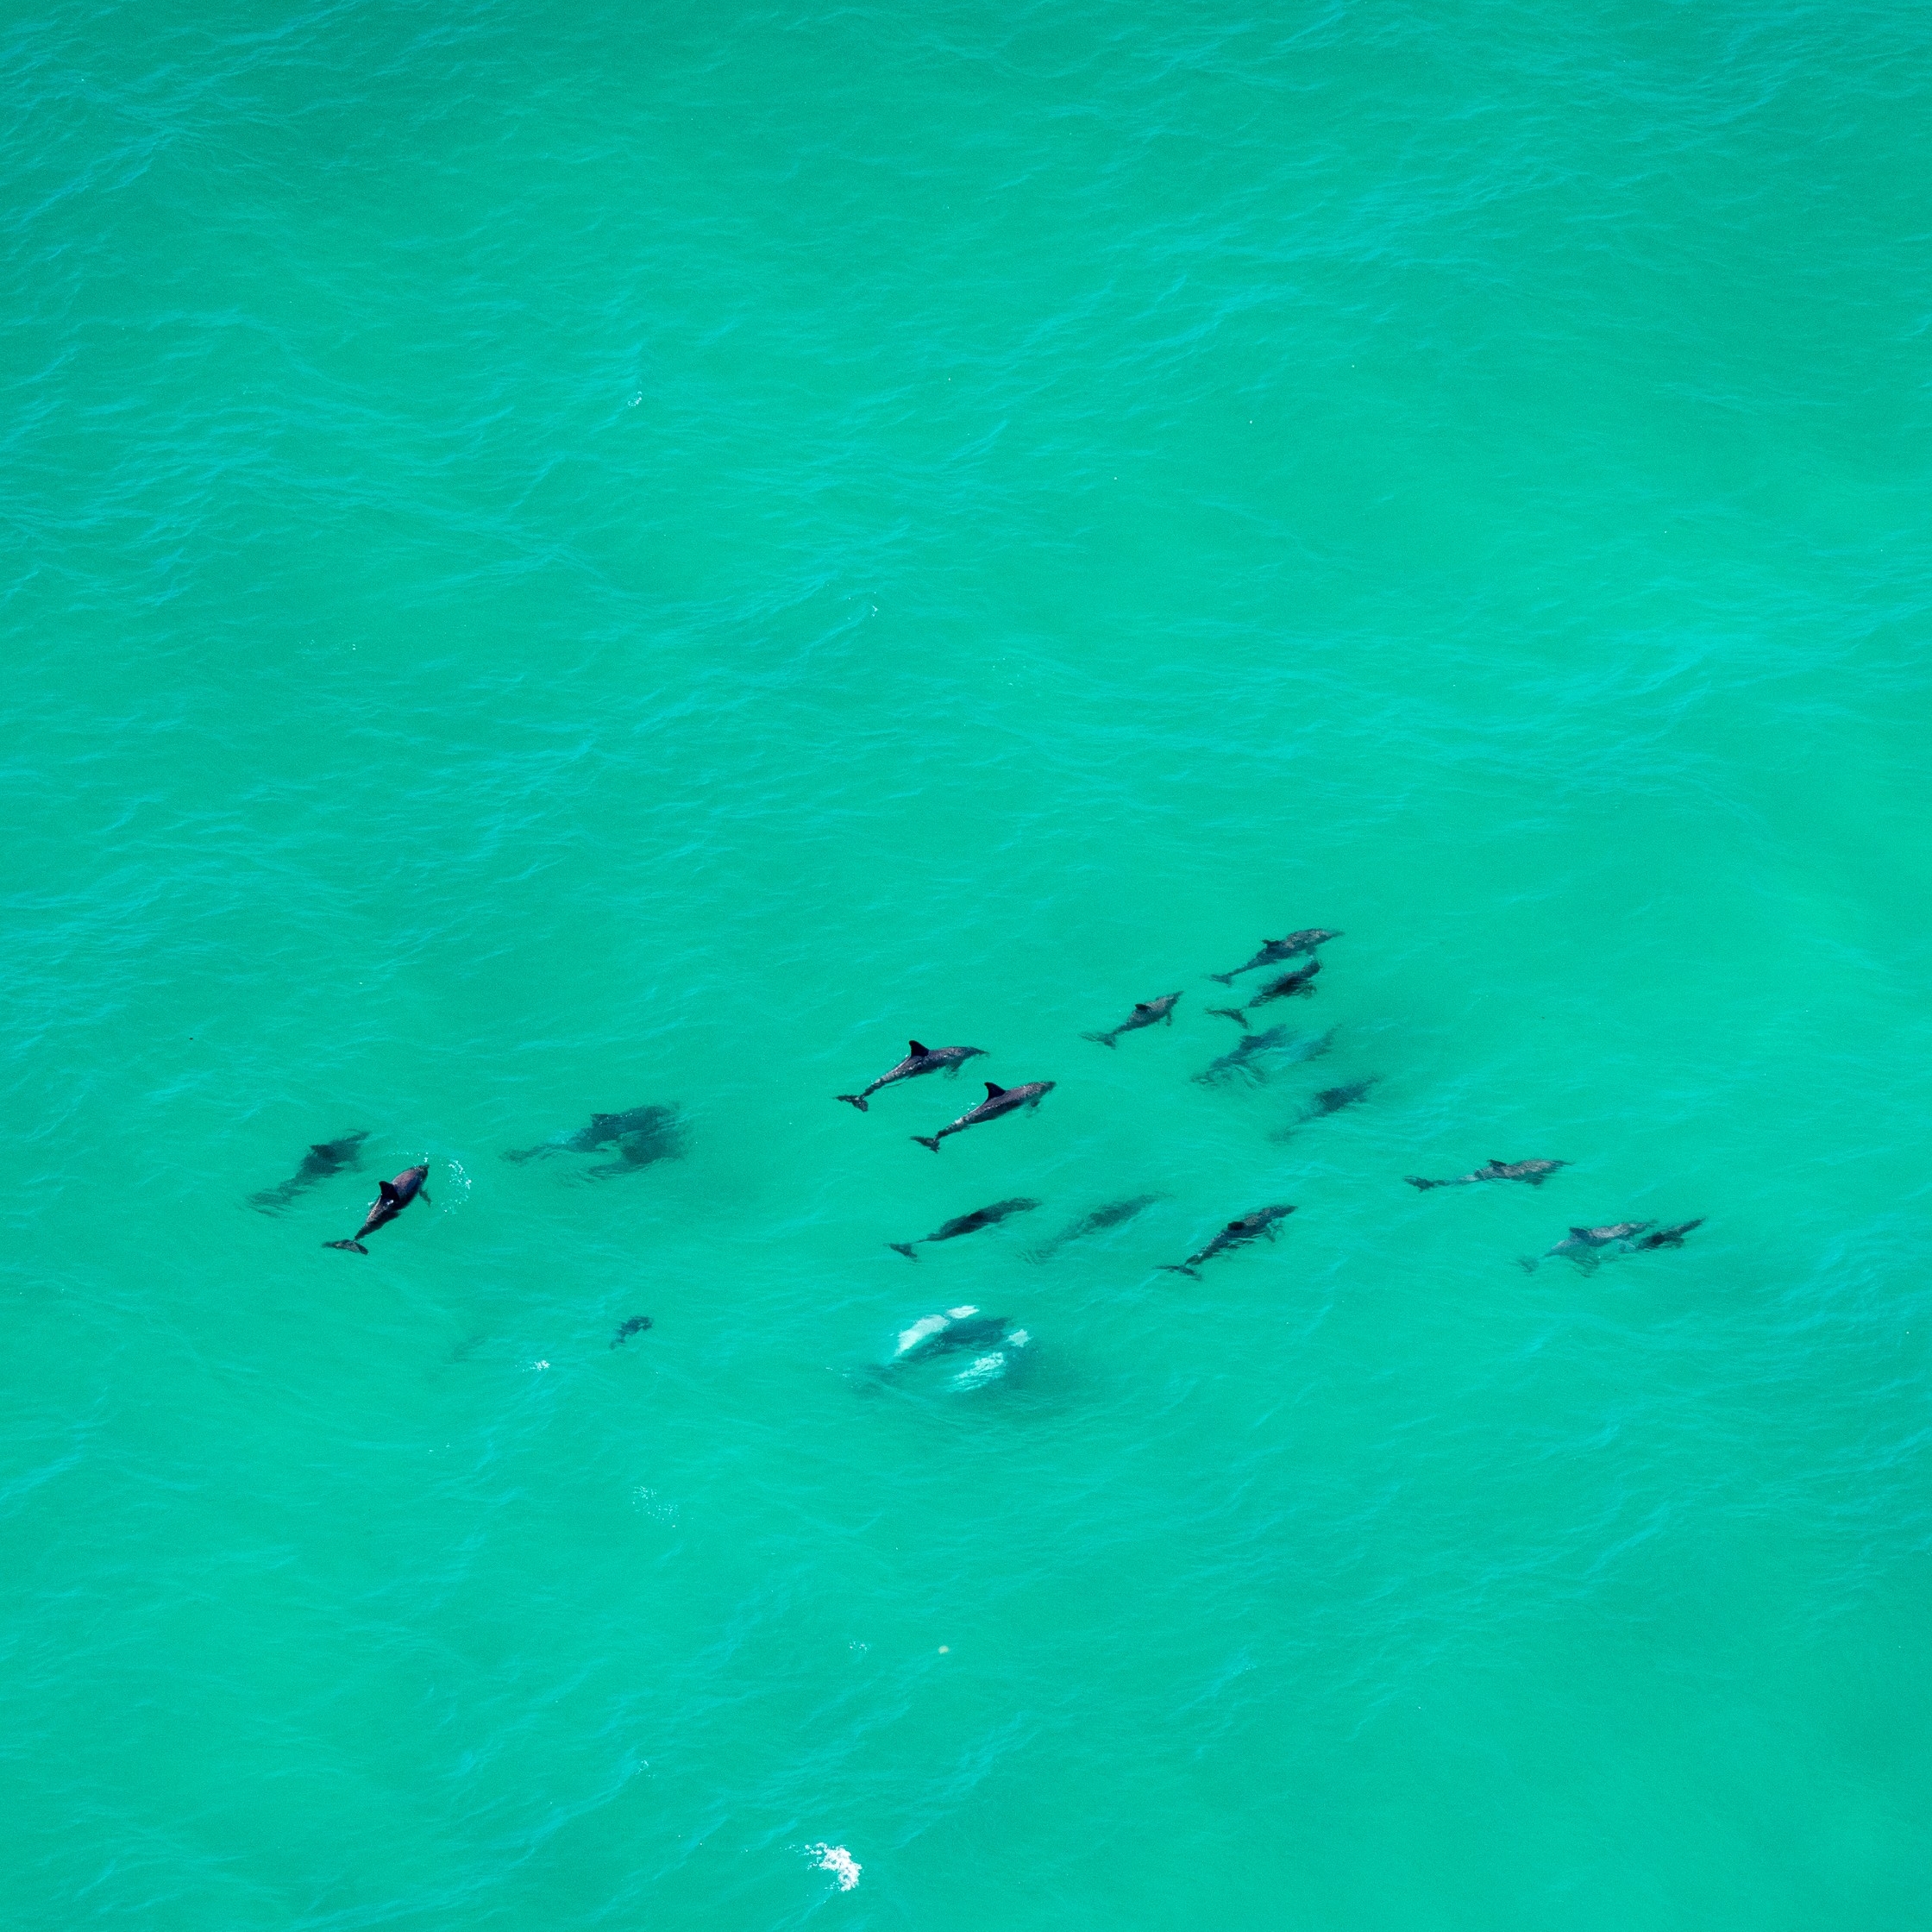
[249,925,1704,1387]
